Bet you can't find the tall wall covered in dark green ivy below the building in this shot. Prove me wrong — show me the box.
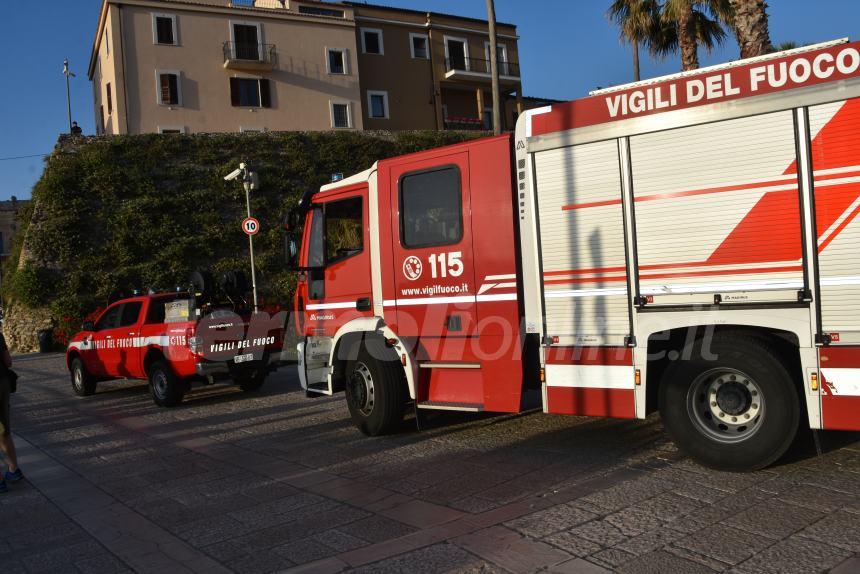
[3,132,481,348]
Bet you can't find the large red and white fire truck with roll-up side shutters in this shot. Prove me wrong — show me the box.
[293,40,860,470]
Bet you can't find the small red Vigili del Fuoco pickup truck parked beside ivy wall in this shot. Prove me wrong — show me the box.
[66,293,284,406]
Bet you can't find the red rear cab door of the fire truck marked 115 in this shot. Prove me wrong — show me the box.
[384,152,480,352]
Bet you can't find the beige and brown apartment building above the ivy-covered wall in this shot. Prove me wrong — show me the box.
[89,0,523,134]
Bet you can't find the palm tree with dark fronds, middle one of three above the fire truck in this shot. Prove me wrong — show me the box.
[663,0,732,71]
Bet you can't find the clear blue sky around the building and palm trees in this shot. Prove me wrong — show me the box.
[0,0,860,199]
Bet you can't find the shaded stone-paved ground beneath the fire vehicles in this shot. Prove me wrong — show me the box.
[0,355,860,574]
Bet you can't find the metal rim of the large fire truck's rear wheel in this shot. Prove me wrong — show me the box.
[687,367,765,444]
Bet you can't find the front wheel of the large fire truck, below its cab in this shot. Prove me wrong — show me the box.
[345,339,406,436]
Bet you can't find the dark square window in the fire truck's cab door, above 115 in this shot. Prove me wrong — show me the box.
[400,166,463,249]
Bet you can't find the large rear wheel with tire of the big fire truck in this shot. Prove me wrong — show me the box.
[659,333,801,472]
